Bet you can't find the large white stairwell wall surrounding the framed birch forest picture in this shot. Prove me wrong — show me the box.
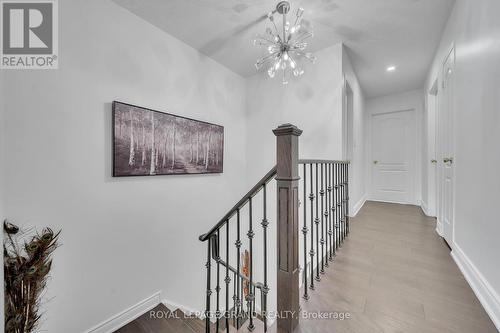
[0,0,249,333]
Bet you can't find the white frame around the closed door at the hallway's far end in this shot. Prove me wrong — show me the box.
[367,107,421,205]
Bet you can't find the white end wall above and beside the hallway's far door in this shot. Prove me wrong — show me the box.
[365,90,424,205]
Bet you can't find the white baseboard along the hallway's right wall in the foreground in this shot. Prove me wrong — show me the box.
[451,244,500,332]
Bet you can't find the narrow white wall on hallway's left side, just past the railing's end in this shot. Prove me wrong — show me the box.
[342,47,366,214]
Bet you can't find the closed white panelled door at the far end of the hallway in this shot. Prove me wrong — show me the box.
[371,110,416,204]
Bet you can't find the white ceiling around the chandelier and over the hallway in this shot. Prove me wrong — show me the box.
[113,0,454,97]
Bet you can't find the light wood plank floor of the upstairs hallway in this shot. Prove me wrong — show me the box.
[290,202,497,333]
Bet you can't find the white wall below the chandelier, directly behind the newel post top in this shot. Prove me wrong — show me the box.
[246,44,343,182]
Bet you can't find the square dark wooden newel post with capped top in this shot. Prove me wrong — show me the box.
[273,124,302,333]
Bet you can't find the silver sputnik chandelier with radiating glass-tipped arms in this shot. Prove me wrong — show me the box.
[254,1,316,84]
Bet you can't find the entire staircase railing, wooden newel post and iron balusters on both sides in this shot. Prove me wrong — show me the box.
[199,124,349,333]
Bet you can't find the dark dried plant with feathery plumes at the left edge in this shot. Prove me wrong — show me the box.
[3,221,60,333]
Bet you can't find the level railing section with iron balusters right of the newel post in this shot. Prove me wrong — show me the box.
[299,160,349,300]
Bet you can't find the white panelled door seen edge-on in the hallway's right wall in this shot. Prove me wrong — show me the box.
[439,50,455,244]
